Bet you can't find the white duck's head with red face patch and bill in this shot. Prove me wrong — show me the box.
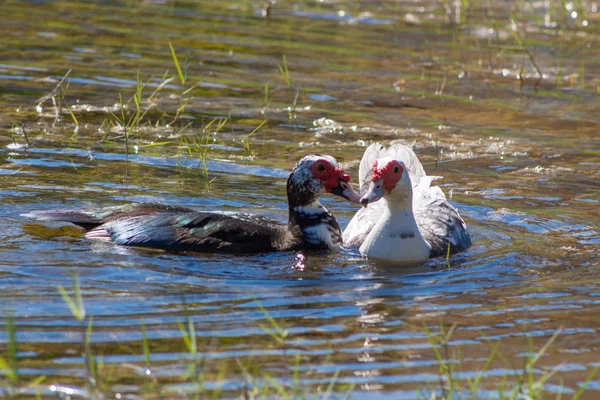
[360,157,412,207]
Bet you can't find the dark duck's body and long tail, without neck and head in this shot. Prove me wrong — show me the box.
[25,203,302,253]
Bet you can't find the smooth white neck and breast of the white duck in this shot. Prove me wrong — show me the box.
[360,191,431,262]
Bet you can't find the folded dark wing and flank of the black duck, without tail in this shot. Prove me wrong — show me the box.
[102,212,301,253]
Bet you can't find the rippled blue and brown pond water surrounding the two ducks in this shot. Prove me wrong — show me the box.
[0,1,600,399]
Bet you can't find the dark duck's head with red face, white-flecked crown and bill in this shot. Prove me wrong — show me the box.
[287,154,360,205]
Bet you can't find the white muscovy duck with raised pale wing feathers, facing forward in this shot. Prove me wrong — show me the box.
[343,144,471,262]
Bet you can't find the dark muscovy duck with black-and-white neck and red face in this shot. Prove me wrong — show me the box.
[23,154,360,253]
